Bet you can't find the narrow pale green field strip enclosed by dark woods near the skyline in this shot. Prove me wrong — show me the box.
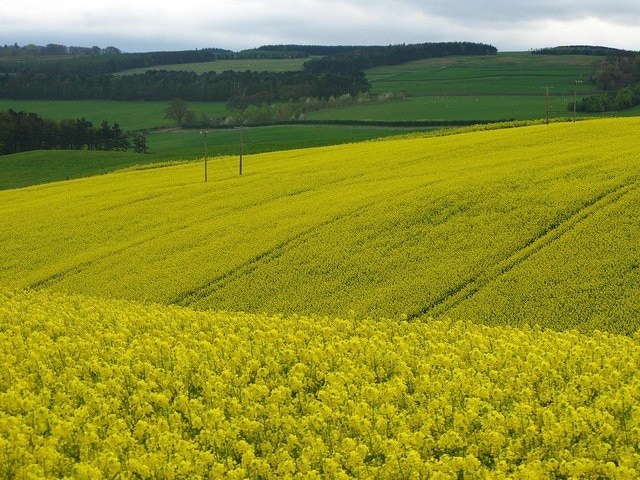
[121,57,312,75]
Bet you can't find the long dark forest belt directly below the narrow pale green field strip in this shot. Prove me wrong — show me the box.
[0,70,371,104]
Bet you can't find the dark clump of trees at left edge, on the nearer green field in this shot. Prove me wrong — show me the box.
[0,110,147,155]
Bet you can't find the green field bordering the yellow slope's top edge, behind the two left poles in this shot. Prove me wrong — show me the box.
[0,125,436,190]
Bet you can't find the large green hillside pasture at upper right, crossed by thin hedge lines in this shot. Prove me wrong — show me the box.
[307,52,612,121]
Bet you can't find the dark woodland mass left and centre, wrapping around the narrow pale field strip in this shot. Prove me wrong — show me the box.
[0,42,497,104]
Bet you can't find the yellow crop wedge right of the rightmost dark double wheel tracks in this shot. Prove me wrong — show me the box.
[447,182,640,333]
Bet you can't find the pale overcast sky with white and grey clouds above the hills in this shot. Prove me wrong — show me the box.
[0,0,640,52]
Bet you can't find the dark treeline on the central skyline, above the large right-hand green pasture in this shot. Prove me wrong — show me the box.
[304,42,498,73]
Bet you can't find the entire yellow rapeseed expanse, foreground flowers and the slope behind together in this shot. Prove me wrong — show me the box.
[0,119,640,480]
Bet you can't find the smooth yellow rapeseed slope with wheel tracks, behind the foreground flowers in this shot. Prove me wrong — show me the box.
[0,119,640,333]
